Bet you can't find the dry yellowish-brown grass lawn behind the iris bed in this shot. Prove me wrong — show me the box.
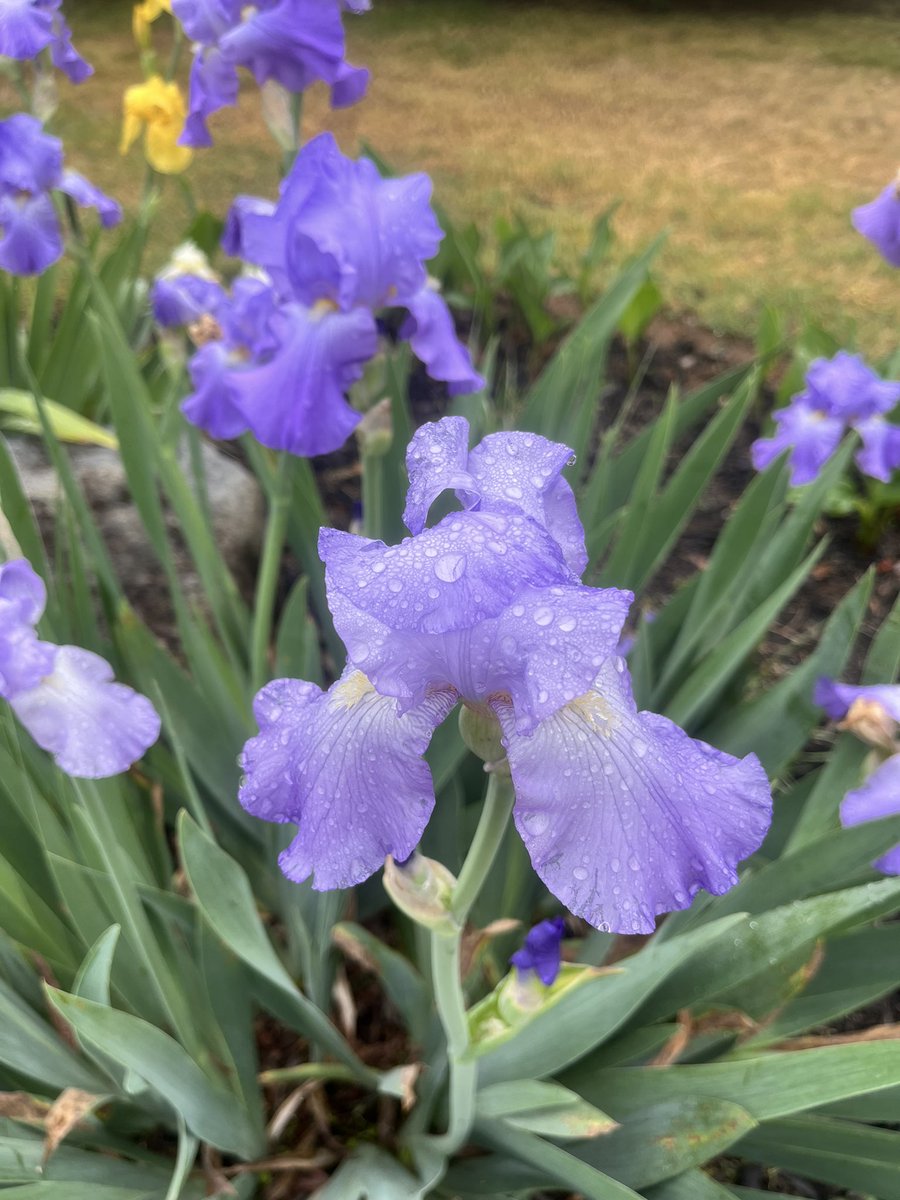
[10,0,900,353]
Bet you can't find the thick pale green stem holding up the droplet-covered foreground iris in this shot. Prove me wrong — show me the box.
[431,769,514,1156]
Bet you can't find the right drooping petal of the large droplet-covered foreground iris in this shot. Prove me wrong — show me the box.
[494,659,772,934]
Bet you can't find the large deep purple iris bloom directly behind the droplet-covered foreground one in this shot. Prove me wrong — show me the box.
[182,133,484,456]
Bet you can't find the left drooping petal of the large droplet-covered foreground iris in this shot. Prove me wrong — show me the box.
[240,672,456,890]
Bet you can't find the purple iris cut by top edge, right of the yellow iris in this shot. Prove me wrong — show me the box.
[172,0,368,146]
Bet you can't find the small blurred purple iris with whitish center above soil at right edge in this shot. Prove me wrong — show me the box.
[751,350,900,487]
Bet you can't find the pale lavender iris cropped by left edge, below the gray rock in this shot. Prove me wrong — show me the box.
[0,558,160,779]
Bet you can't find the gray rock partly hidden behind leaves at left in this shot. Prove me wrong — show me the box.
[10,437,265,640]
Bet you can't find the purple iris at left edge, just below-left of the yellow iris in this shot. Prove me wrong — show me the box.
[0,113,122,275]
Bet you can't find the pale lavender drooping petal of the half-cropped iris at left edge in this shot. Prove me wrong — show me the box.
[10,646,160,779]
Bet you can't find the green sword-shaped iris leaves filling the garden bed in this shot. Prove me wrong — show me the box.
[0,44,900,1200]
